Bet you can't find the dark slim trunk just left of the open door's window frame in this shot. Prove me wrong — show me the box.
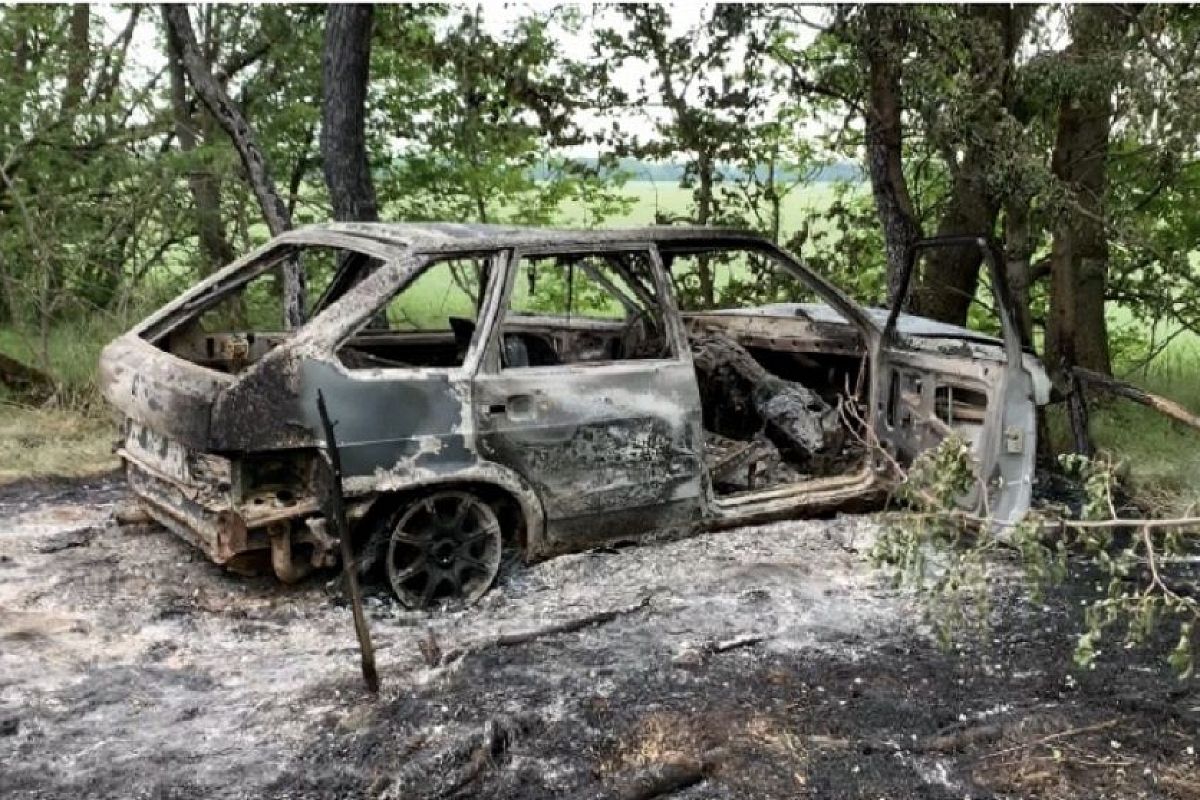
[863,6,920,303]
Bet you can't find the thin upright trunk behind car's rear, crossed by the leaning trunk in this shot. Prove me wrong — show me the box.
[167,25,234,275]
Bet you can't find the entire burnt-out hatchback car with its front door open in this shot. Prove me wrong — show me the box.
[101,223,1049,607]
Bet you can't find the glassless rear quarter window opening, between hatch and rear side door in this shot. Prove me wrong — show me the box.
[337,255,492,369]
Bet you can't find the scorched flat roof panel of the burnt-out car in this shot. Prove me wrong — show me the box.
[296,222,767,251]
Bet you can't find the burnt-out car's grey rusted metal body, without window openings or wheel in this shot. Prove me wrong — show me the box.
[100,223,1048,578]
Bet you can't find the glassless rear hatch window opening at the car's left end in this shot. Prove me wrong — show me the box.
[146,246,379,374]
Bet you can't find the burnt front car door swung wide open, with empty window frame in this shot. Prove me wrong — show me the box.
[874,236,1037,522]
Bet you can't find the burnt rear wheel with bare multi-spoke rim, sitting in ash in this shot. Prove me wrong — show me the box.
[384,489,503,609]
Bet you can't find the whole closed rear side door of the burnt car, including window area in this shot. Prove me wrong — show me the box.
[473,245,703,547]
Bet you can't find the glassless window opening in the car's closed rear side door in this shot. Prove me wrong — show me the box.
[499,252,673,369]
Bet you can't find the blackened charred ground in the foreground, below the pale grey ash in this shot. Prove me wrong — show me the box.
[266,578,1200,799]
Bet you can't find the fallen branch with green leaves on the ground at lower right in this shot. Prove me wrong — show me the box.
[871,435,1200,676]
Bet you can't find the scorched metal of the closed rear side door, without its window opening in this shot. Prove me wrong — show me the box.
[473,239,708,552]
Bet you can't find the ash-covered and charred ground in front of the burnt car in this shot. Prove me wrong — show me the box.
[0,479,1200,800]
